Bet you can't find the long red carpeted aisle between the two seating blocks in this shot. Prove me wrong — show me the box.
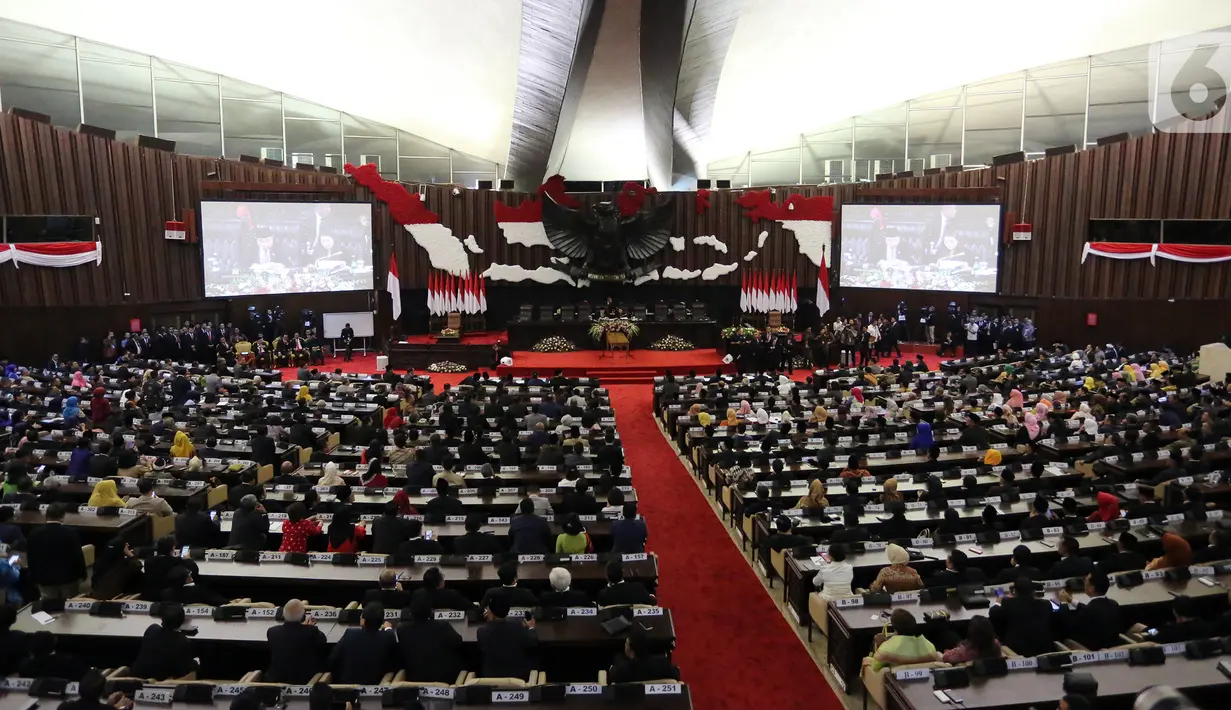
[608,385,842,710]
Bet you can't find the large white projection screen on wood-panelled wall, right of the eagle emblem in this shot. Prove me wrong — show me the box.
[838,204,1001,293]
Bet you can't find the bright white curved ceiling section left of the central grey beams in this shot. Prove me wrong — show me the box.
[0,0,522,164]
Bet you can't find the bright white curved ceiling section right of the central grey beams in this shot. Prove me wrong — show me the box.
[705,0,1231,160]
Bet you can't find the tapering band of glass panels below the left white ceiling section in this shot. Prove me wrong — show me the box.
[0,18,499,187]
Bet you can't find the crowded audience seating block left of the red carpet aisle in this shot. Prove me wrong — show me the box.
[0,362,691,709]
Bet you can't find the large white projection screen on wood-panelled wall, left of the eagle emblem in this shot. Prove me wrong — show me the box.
[201,202,372,298]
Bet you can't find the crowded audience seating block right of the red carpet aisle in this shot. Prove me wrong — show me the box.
[655,348,1231,710]
